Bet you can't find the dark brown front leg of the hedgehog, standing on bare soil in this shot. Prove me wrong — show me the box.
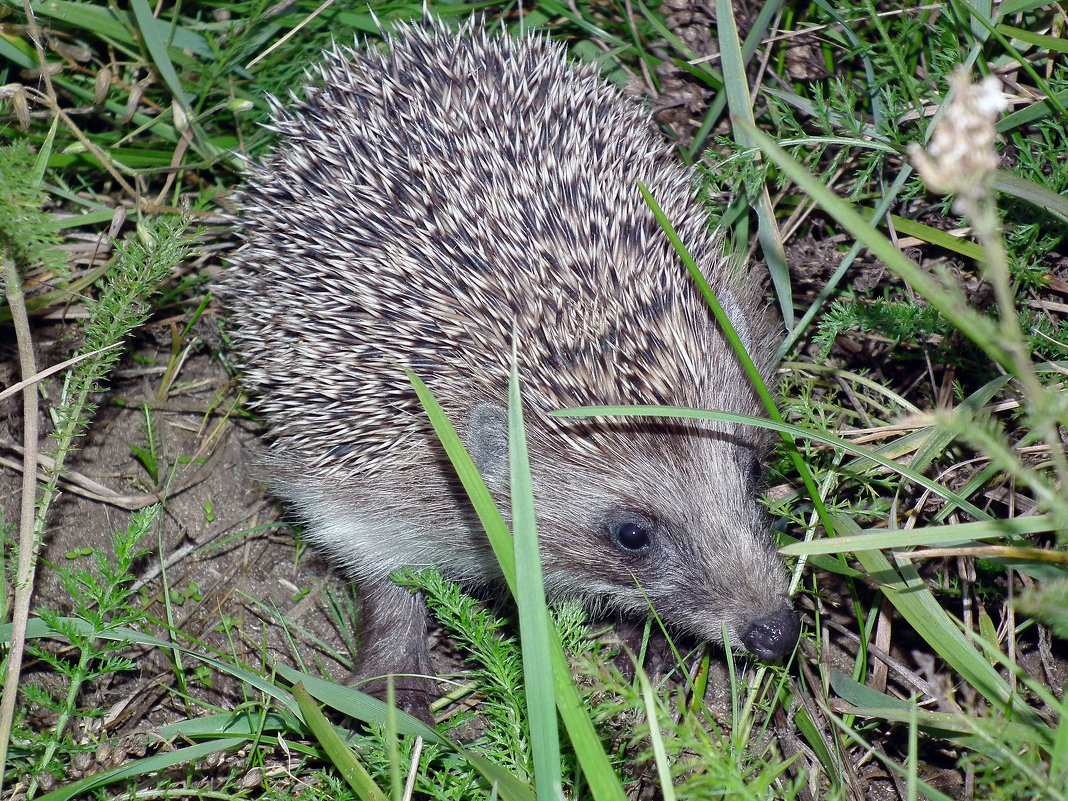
[357,577,436,727]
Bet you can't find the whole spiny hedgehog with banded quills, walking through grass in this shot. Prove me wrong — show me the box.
[219,18,799,719]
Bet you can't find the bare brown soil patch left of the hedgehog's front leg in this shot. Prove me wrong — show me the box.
[0,311,358,700]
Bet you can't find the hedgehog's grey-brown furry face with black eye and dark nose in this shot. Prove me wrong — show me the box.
[532,425,799,659]
